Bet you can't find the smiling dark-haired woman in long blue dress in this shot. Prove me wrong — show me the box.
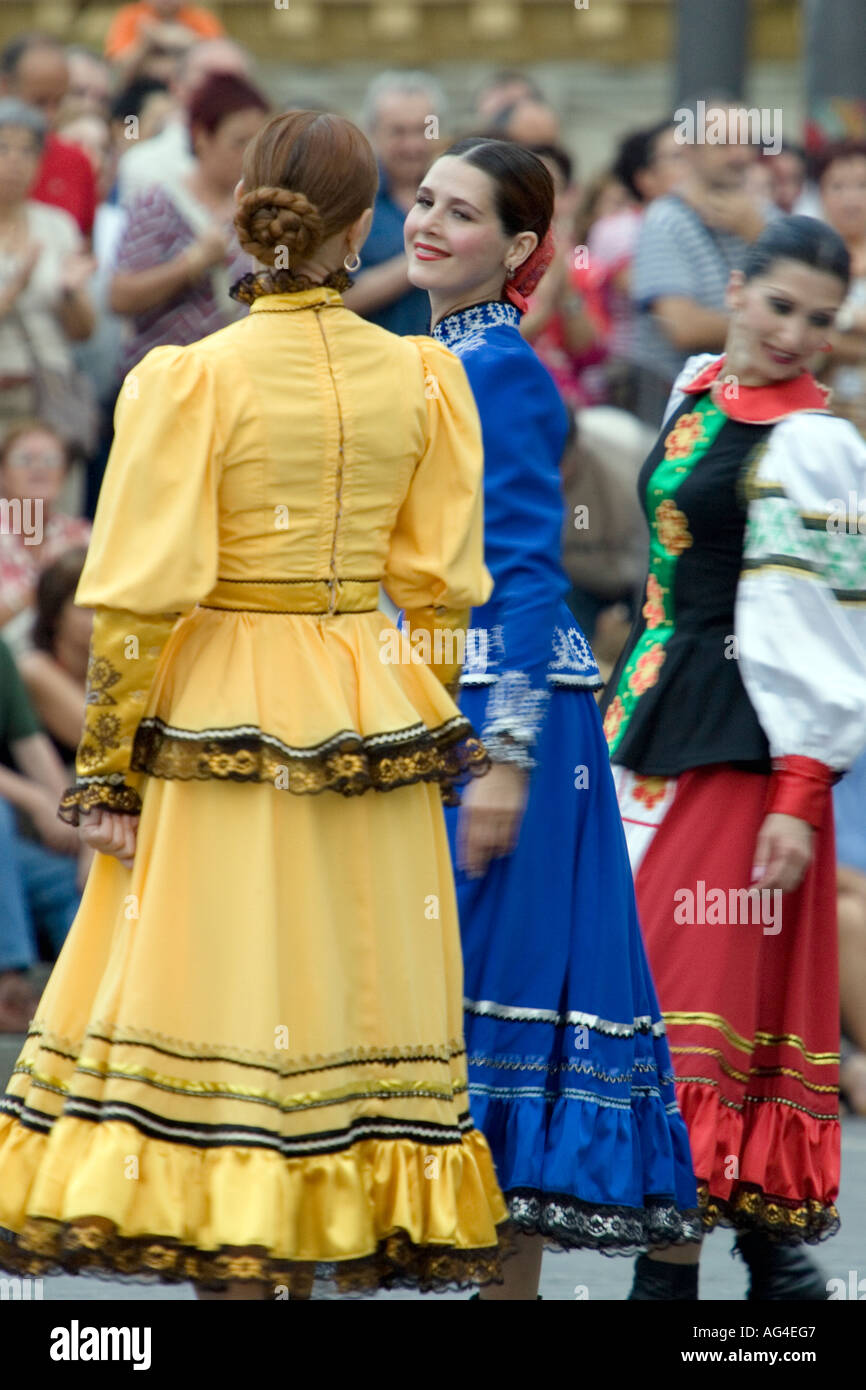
[406,139,701,1300]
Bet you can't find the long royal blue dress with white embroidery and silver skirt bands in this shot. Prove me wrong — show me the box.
[434,303,701,1254]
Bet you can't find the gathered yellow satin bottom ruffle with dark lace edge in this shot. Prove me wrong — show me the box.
[0,1116,512,1297]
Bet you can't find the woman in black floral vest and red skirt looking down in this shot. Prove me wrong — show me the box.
[605,217,866,1300]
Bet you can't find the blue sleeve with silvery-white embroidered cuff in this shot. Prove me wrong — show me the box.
[461,346,569,767]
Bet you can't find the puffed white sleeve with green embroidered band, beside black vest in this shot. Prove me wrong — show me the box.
[734,411,866,771]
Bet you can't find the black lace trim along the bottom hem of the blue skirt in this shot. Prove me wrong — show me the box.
[505,1187,703,1255]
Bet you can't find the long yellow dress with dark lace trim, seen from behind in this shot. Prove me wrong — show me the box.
[0,288,506,1290]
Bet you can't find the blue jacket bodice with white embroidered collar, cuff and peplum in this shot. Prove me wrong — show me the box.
[432,302,603,763]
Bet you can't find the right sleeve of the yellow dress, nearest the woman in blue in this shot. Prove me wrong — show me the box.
[384,338,493,692]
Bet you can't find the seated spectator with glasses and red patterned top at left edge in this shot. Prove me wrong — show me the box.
[0,420,90,651]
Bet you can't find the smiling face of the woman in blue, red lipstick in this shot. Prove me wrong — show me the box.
[403,154,520,299]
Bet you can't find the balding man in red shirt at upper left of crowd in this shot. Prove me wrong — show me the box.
[0,33,96,238]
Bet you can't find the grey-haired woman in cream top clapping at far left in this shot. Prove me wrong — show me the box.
[0,97,95,452]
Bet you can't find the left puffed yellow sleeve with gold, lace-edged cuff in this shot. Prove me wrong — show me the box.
[60,348,222,824]
